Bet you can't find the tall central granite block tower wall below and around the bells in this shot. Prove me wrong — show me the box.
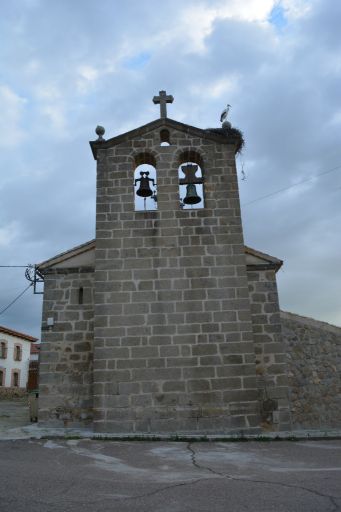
[94,123,260,433]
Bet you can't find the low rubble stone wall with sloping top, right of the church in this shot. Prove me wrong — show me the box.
[281,312,341,429]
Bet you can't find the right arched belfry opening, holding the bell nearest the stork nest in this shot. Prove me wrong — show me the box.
[178,150,205,210]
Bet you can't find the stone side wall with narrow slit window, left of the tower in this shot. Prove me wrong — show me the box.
[39,268,94,427]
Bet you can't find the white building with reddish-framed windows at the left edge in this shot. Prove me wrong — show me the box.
[0,326,37,388]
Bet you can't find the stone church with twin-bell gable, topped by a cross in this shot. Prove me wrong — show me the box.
[37,91,291,434]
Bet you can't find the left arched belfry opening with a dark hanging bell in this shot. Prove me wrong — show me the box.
[134,152,157,211]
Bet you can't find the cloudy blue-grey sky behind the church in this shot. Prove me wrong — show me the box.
[0,0,341,336]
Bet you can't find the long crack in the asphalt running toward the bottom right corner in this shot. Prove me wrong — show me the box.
[187,443,341,512]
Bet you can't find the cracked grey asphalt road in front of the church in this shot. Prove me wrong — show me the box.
[0,440,341,512]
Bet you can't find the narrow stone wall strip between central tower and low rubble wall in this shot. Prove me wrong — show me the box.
[247,269,291,430]
